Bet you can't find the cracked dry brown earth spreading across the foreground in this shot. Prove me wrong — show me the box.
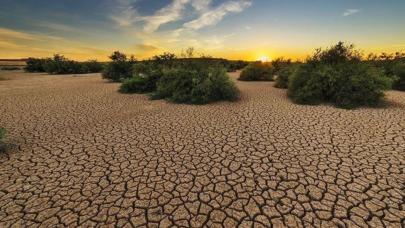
[0,73,405,227]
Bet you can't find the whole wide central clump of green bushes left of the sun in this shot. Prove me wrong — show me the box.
[120,53,239,104]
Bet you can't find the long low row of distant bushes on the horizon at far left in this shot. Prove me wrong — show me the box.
[25,54,103,74]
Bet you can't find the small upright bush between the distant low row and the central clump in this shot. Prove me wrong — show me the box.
[103,51,135,82]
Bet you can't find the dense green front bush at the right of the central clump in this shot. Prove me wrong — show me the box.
[152,68,239,104]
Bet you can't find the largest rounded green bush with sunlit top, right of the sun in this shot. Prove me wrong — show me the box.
[288,42,392,108]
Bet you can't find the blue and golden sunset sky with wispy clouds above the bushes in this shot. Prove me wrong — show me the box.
[0,0,405,61]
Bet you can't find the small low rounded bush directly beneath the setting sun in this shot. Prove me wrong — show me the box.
[238,62,274,81]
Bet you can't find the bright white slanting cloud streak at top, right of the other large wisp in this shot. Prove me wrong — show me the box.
[184,0,252,30]
